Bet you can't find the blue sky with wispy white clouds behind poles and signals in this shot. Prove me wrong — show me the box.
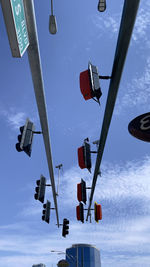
[0,0,150,267]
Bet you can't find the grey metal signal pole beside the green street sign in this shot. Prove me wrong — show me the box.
[24,0,59,227]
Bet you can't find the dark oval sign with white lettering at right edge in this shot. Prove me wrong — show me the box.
[128,112,150,142]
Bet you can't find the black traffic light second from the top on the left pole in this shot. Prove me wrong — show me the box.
[34,175,46,203]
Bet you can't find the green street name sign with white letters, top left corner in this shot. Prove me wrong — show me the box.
[1,0,29,57]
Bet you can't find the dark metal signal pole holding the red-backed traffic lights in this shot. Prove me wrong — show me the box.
[86,0,140,221]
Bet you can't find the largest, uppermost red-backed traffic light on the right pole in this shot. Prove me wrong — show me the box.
[80,62,102,103]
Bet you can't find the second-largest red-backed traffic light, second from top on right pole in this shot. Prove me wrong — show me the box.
[78,139,92,172]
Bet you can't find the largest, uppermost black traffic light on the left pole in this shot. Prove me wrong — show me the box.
[16,119,35,157]
